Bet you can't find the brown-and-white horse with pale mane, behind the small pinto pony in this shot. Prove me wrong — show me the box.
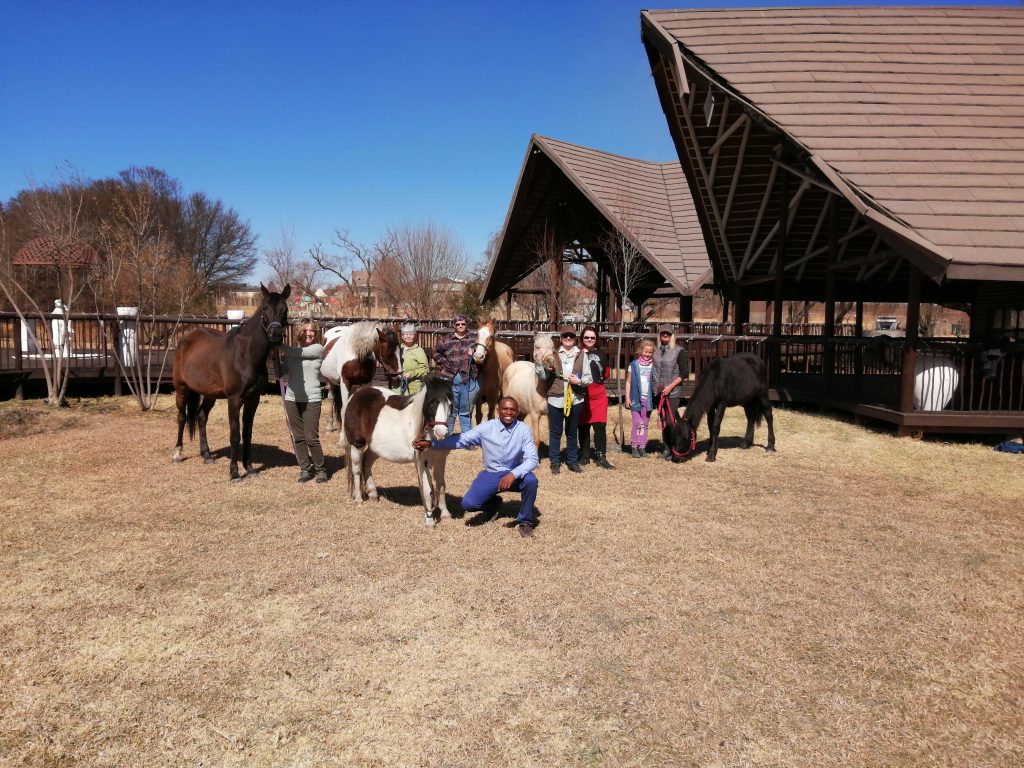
[321,321,401,438]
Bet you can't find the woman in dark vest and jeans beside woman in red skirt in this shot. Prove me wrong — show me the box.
[537,326,592,475]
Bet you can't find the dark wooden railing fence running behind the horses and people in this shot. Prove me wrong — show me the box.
[0,312,1024,423]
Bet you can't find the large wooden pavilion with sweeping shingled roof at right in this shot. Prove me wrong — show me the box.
[641,6,1024,433]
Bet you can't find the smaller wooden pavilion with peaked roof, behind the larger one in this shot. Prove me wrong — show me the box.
[480,134,711,323]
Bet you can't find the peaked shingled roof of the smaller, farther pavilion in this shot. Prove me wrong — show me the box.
[482,134,711,300]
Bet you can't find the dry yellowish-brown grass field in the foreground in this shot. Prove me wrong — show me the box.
[0,398,1024,768]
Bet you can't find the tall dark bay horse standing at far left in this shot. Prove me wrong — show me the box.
[171,284,292,481]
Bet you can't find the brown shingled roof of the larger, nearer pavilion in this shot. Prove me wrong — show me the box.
[643,6,1024,281]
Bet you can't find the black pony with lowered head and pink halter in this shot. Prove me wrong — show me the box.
[662,352,775,462]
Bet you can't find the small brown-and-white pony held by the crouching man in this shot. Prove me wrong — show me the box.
[343,377,453,526]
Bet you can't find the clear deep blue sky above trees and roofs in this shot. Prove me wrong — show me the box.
[0,0,1007,278]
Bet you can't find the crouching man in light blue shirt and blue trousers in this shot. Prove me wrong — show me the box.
[413,397,539,537]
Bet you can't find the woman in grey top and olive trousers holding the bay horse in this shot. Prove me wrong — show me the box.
[280,323,327,482]
